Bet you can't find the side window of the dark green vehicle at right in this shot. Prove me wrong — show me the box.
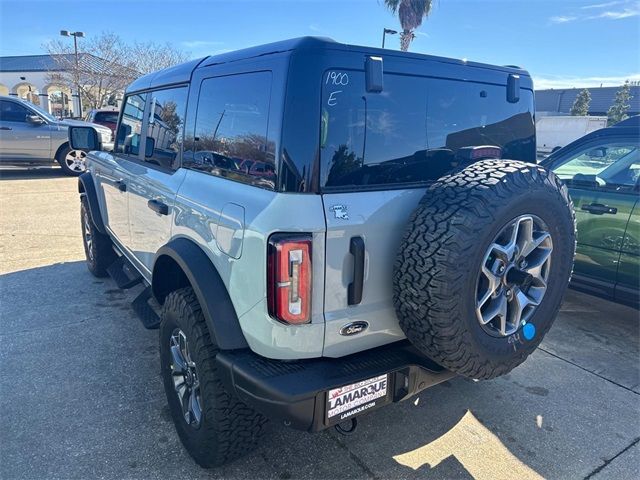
[553,142,640,191]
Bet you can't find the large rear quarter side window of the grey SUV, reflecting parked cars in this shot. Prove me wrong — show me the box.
[183,72,275,189]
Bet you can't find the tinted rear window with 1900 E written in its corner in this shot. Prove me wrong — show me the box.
[320,70,535,188]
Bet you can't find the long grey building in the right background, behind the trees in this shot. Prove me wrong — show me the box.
[536,85,640,116]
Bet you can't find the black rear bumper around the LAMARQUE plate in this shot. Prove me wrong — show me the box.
[217,341,455,432]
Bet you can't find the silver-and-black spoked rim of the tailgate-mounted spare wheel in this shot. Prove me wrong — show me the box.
[476,215,553,337]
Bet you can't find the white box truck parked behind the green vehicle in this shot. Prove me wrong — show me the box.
[536,116,607,155]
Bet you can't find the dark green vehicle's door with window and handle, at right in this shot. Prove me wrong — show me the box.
[549,136,640,296]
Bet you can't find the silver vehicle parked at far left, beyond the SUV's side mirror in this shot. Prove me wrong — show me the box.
[0,96,113,176]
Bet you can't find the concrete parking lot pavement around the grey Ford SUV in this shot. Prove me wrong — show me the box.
[0,169,640,480]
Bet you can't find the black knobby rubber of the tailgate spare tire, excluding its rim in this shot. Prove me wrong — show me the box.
[393,160,575,379]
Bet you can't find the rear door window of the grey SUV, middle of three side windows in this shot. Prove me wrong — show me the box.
[144,87,187,170]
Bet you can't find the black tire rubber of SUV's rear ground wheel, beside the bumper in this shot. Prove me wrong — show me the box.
[161,287,267,468]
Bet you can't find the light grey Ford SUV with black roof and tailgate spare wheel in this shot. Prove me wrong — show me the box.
[70,38,575,466]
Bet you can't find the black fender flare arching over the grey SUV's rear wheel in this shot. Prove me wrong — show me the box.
[151,238,249,350]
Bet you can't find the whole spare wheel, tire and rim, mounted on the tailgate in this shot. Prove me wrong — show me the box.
[393,160,576,379]
